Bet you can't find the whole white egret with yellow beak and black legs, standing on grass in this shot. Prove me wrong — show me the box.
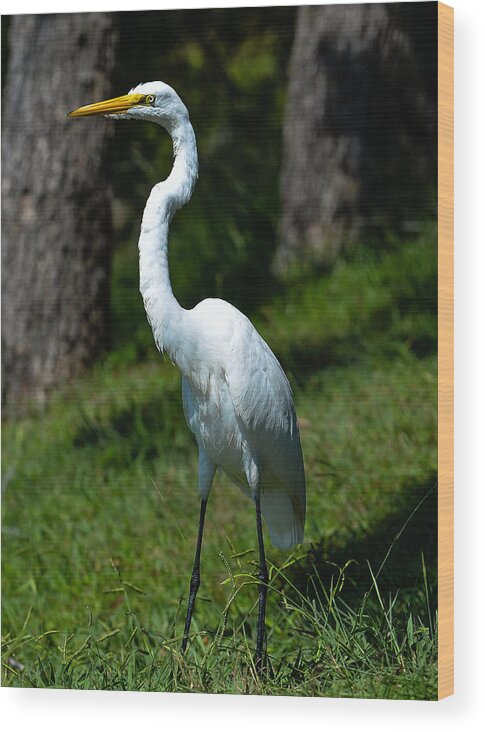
[69,81,306,670]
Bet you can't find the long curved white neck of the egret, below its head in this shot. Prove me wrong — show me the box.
[138,118,198,365]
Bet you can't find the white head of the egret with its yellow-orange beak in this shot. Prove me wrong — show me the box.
[68,81,189,130]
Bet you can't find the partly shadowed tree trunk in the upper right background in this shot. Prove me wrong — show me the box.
[275,2,437,274]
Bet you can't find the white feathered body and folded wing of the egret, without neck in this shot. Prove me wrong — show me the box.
[178,299,305,549]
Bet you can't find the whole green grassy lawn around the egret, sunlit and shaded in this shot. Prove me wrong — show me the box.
[2,237,437,698]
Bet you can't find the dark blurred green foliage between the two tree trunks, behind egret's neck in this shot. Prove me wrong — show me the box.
[111,8,295,320]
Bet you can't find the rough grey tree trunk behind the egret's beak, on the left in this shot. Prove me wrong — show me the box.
[2,13,116,413]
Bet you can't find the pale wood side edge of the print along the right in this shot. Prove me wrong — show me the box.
[438,2,454,699]
